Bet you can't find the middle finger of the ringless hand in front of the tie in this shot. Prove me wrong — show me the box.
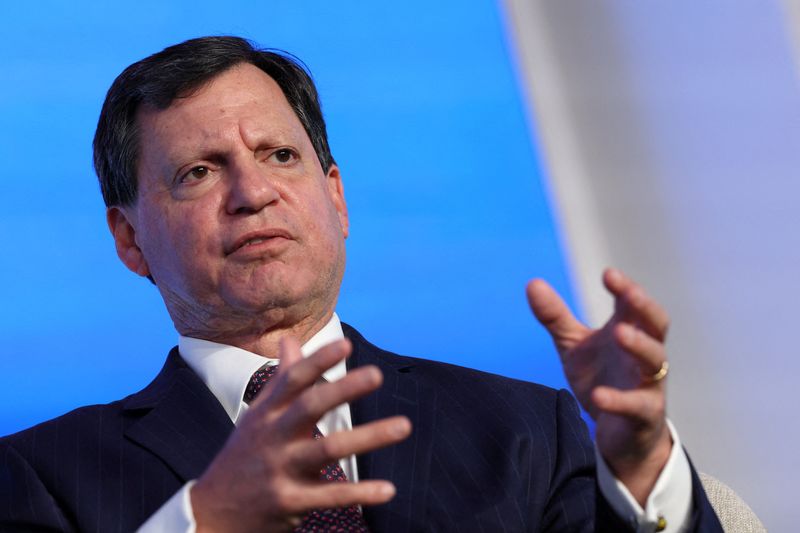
[277,365,383,434]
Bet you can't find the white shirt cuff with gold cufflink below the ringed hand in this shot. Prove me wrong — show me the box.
[595,420,692,533]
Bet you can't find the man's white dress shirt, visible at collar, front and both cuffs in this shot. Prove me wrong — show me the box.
[138,313,692,533]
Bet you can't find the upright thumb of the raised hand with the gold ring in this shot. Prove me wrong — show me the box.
[526,279,588,350]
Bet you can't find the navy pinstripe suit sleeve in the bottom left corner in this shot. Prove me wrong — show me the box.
[0,444,75,533]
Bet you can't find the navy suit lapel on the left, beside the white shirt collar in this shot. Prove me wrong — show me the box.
[124,348,233,481]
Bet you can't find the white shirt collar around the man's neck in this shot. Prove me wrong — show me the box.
[178,313,347,423]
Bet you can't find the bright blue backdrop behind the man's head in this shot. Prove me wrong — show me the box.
[0,0,574,434]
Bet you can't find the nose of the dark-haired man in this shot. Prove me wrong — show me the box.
[225,158,280,215]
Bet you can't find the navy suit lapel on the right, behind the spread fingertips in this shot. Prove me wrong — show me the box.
[343,325,436,531]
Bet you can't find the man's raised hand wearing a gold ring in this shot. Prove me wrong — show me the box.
[527,269,672,504]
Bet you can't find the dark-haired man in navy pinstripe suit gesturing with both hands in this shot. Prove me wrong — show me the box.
[0,37,719,531]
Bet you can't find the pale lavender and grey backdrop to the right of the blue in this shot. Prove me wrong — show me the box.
[504,0,800,531]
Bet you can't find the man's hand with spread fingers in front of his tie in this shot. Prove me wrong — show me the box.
[191,339,411,532]
